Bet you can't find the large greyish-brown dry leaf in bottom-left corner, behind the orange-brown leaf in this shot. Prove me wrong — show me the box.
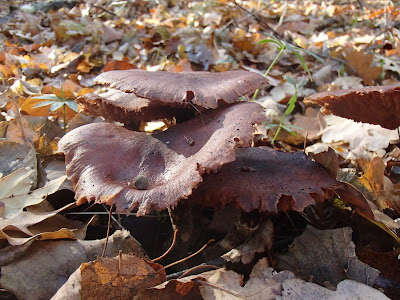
[0,231,143,300]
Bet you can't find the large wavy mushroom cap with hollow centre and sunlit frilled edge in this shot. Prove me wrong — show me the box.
[59,102,265,215]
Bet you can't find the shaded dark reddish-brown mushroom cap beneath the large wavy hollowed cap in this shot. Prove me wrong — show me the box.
[188,147,344,212]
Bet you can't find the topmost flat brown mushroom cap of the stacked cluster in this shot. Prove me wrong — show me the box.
[95,70,267,108]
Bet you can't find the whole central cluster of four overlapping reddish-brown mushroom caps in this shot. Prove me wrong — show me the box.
[59,70,372,216]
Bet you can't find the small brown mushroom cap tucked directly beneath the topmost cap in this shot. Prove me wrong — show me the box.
[76,89,195,127]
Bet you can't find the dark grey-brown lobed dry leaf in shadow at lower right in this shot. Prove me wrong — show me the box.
[276,225,379,287]
